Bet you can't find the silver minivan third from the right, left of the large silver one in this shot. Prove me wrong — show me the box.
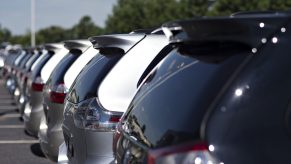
[38,40,93,161]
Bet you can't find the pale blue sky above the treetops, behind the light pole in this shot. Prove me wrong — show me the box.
[0,0,117,35]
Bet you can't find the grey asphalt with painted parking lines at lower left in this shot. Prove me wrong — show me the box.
[0,79,53,164]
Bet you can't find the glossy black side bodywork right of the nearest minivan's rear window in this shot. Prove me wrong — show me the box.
[206,24,291,164]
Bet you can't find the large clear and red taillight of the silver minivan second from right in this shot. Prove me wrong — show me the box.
[73,97,122,131]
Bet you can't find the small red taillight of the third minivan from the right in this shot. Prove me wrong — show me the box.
[49,83,67,104]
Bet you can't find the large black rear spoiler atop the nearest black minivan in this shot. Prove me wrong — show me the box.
[162,12,291,49]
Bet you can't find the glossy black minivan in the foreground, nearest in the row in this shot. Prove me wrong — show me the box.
[115,12,291,164]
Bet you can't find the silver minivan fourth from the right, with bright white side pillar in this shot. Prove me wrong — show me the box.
[23,43,68,137]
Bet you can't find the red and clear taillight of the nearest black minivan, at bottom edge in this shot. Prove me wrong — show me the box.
[148,143,223,164]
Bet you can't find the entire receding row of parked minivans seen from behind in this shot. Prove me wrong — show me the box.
[0,12,291,164]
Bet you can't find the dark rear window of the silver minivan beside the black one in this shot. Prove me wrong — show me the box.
[68,54,122,103]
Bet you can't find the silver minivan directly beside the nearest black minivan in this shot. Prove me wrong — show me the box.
[63,31,168,163]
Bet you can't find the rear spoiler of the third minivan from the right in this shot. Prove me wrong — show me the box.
[64,39,92,53]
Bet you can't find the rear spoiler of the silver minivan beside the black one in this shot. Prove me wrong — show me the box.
[89,34,145,55]
